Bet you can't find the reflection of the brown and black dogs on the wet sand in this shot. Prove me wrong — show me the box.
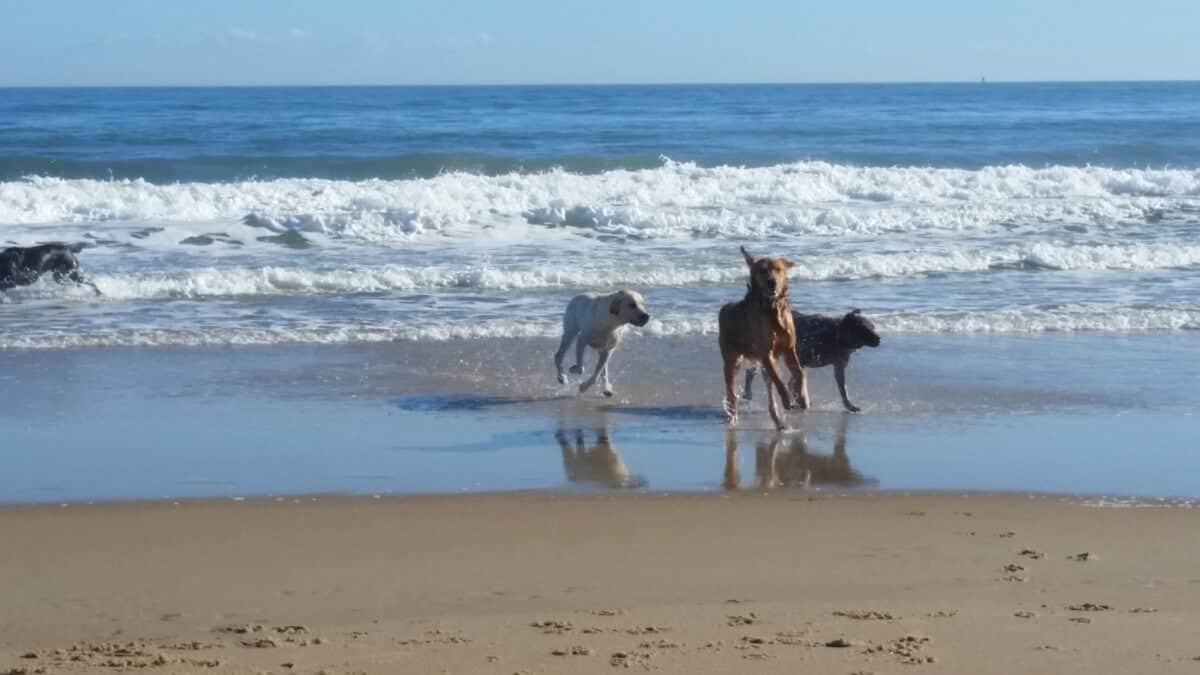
[721,414,875,490]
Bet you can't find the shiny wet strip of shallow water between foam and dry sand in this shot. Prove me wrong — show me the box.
[0,334,1200,502]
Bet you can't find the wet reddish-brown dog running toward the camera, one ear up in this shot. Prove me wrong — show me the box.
[718,246,809,429]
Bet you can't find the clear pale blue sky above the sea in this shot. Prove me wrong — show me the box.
[0,0,1200,85]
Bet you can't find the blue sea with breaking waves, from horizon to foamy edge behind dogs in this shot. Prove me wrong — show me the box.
[0,83,1200,348]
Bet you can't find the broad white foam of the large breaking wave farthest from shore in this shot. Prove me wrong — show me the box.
[0,161,1200,241]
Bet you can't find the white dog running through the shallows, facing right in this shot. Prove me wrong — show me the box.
[554,291,650,396]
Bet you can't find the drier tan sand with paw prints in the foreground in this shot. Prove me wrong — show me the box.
[0,491,1200,675]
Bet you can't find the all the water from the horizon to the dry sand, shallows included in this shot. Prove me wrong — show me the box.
[0,83,1200,503]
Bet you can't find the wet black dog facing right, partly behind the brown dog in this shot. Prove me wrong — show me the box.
[742,310,880,412]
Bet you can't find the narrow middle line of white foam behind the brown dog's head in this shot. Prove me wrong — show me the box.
[13,244,1171,300]
